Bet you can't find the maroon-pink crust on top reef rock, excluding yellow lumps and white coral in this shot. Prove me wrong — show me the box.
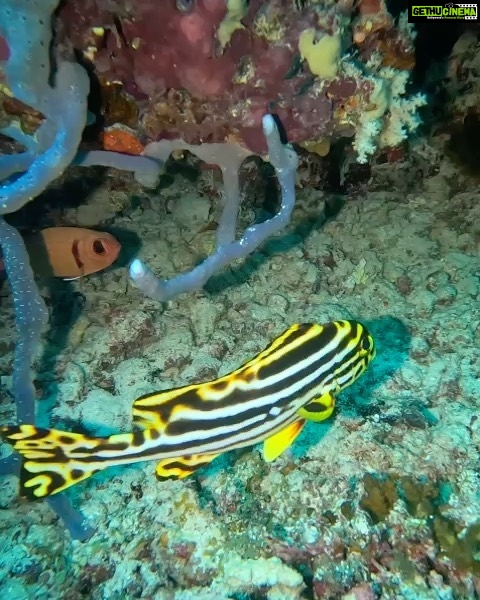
[57,0,382,154]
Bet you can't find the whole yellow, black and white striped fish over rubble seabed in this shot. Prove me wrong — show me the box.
[0,321,375,500]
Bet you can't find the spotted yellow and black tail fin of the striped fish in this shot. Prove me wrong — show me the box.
[0,425,107,500]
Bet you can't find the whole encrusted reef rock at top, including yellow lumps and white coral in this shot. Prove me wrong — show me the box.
[53,0,425,161]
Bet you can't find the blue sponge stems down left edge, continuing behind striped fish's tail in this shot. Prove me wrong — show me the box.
[0,0,93,540]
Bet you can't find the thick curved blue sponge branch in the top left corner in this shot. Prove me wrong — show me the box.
[0,0,90,214]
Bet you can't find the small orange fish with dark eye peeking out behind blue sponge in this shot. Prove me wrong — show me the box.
[0,227,121,280]
